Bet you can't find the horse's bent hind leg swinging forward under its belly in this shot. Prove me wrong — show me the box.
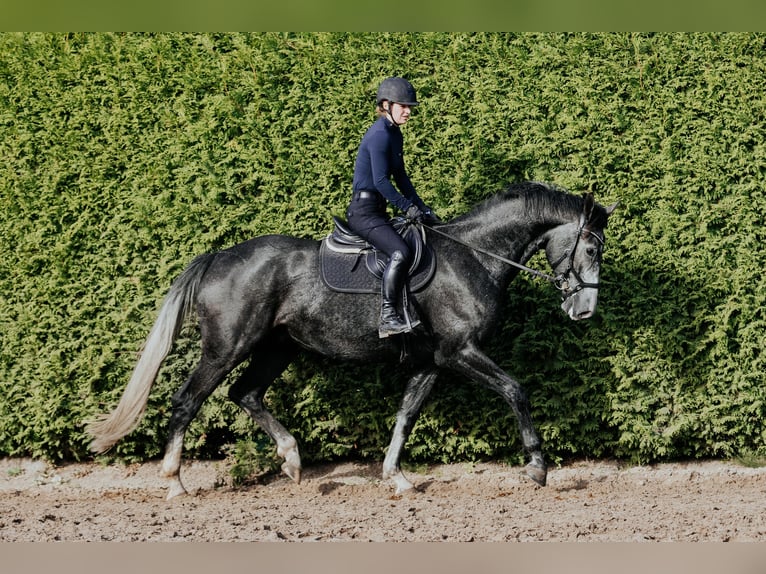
[229,341,302,483]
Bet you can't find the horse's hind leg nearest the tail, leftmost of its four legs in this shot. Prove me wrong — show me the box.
[160,356,234,500]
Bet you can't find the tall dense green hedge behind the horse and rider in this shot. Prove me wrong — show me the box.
[0,33,766,468]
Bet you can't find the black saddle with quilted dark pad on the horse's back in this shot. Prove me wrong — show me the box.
[319,216,436,293]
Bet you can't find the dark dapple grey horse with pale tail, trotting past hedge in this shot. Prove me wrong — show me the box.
[87,181,617,499]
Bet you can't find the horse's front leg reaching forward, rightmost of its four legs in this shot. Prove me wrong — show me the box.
[449,346,548,486]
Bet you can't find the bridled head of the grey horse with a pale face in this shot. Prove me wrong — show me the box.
[545,193,618,321]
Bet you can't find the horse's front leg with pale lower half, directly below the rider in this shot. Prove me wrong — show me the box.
[383,370,437,494]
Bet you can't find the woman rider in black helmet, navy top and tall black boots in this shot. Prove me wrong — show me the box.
[346,77,440,338]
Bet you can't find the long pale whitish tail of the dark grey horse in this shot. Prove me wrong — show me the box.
[87,253,215,453]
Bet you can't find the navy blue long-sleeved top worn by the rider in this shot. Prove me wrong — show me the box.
[353,116,427,212]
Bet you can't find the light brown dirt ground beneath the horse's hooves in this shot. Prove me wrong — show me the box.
[0,459,766,542]
